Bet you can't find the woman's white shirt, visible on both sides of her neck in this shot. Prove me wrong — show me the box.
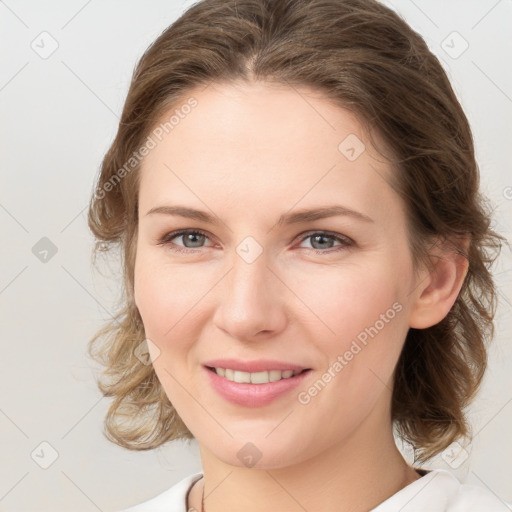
[120,469,512,512]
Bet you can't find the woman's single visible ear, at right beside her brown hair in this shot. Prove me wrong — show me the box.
[409,238,470,329]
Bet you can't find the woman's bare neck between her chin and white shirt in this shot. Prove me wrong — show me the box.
[189,400,419,512]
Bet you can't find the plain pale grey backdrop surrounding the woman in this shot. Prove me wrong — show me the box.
[0,0,512,512]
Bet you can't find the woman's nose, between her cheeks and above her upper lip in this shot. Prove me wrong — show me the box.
[214,246,290,341]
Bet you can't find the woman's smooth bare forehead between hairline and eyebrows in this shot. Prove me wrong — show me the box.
[140,82,397,222]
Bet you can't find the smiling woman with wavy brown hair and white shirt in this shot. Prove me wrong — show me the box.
[89,0,504,512]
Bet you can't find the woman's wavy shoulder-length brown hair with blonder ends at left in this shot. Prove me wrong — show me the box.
[88,0,502,461]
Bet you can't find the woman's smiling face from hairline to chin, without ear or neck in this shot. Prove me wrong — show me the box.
[134,83,422,468]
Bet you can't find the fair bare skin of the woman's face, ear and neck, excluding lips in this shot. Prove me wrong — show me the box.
[134,83,466,512]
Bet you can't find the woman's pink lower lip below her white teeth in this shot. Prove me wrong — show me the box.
[205,368,311,407]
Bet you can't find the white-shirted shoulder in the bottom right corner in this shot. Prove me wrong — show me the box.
[372,469,509,512]
